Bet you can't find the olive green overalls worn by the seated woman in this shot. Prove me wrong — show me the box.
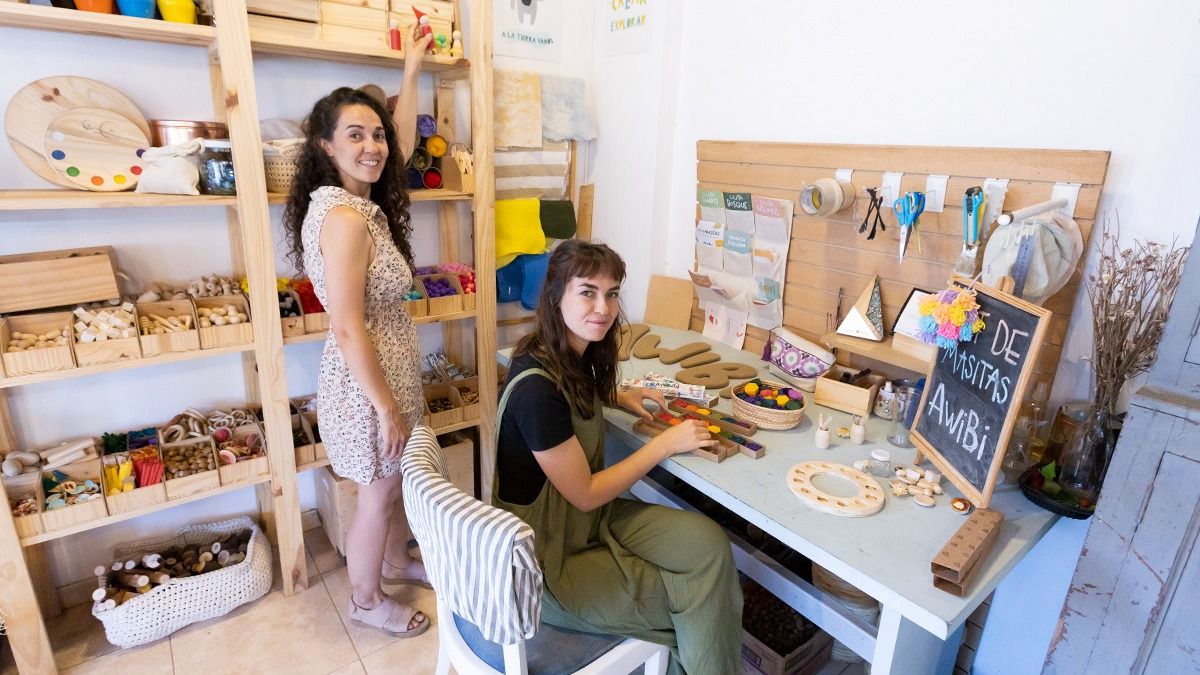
[492,369,742,675]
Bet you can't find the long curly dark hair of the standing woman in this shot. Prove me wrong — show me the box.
[283,86,413,271]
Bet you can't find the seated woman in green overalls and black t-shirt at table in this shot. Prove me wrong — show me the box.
[493,240,742,675]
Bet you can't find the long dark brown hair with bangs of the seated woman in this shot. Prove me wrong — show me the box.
[514,239,625,419]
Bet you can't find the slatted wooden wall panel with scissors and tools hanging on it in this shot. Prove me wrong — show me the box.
[691,141,1109,381]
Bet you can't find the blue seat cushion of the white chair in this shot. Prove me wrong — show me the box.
[454,614,625,675]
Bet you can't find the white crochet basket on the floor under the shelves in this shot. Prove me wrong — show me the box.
[91,516,271,647]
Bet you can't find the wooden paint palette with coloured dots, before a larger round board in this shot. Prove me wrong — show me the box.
[43,108,150,192]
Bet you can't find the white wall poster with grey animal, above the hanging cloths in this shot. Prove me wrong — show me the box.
[492,0,565,61]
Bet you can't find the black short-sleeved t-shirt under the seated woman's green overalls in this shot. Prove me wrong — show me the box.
[496,354,575,504]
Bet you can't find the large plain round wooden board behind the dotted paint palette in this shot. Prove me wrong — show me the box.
[4,76,150,187]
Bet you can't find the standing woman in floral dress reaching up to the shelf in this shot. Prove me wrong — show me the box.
[283,27,430,638]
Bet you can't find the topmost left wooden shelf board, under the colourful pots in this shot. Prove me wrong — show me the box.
[0,2,216,47]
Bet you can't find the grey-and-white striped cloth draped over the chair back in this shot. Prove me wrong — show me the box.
[400,426,541,645]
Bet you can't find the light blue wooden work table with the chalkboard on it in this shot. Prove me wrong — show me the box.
[498,327,1057,675]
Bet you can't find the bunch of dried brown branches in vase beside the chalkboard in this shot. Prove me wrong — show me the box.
[1087,222,1188,413]
